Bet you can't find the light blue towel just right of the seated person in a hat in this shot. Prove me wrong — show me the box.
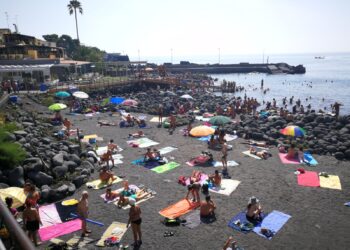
[253,210,292,240]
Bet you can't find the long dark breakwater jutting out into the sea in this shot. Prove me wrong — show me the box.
[164,62,306,74]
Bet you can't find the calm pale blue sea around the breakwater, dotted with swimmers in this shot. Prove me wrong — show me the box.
[147,53,350,114]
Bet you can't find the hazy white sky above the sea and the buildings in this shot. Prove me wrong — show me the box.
[0,0,350,59]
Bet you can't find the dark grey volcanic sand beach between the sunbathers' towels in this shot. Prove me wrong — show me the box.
[13,94,350,249]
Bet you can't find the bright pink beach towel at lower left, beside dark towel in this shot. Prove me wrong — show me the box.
[39,219,81,241]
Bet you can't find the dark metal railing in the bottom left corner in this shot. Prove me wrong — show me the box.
[0,199,35,250]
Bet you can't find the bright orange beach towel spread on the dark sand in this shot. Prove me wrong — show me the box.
[159,199,200,219]
